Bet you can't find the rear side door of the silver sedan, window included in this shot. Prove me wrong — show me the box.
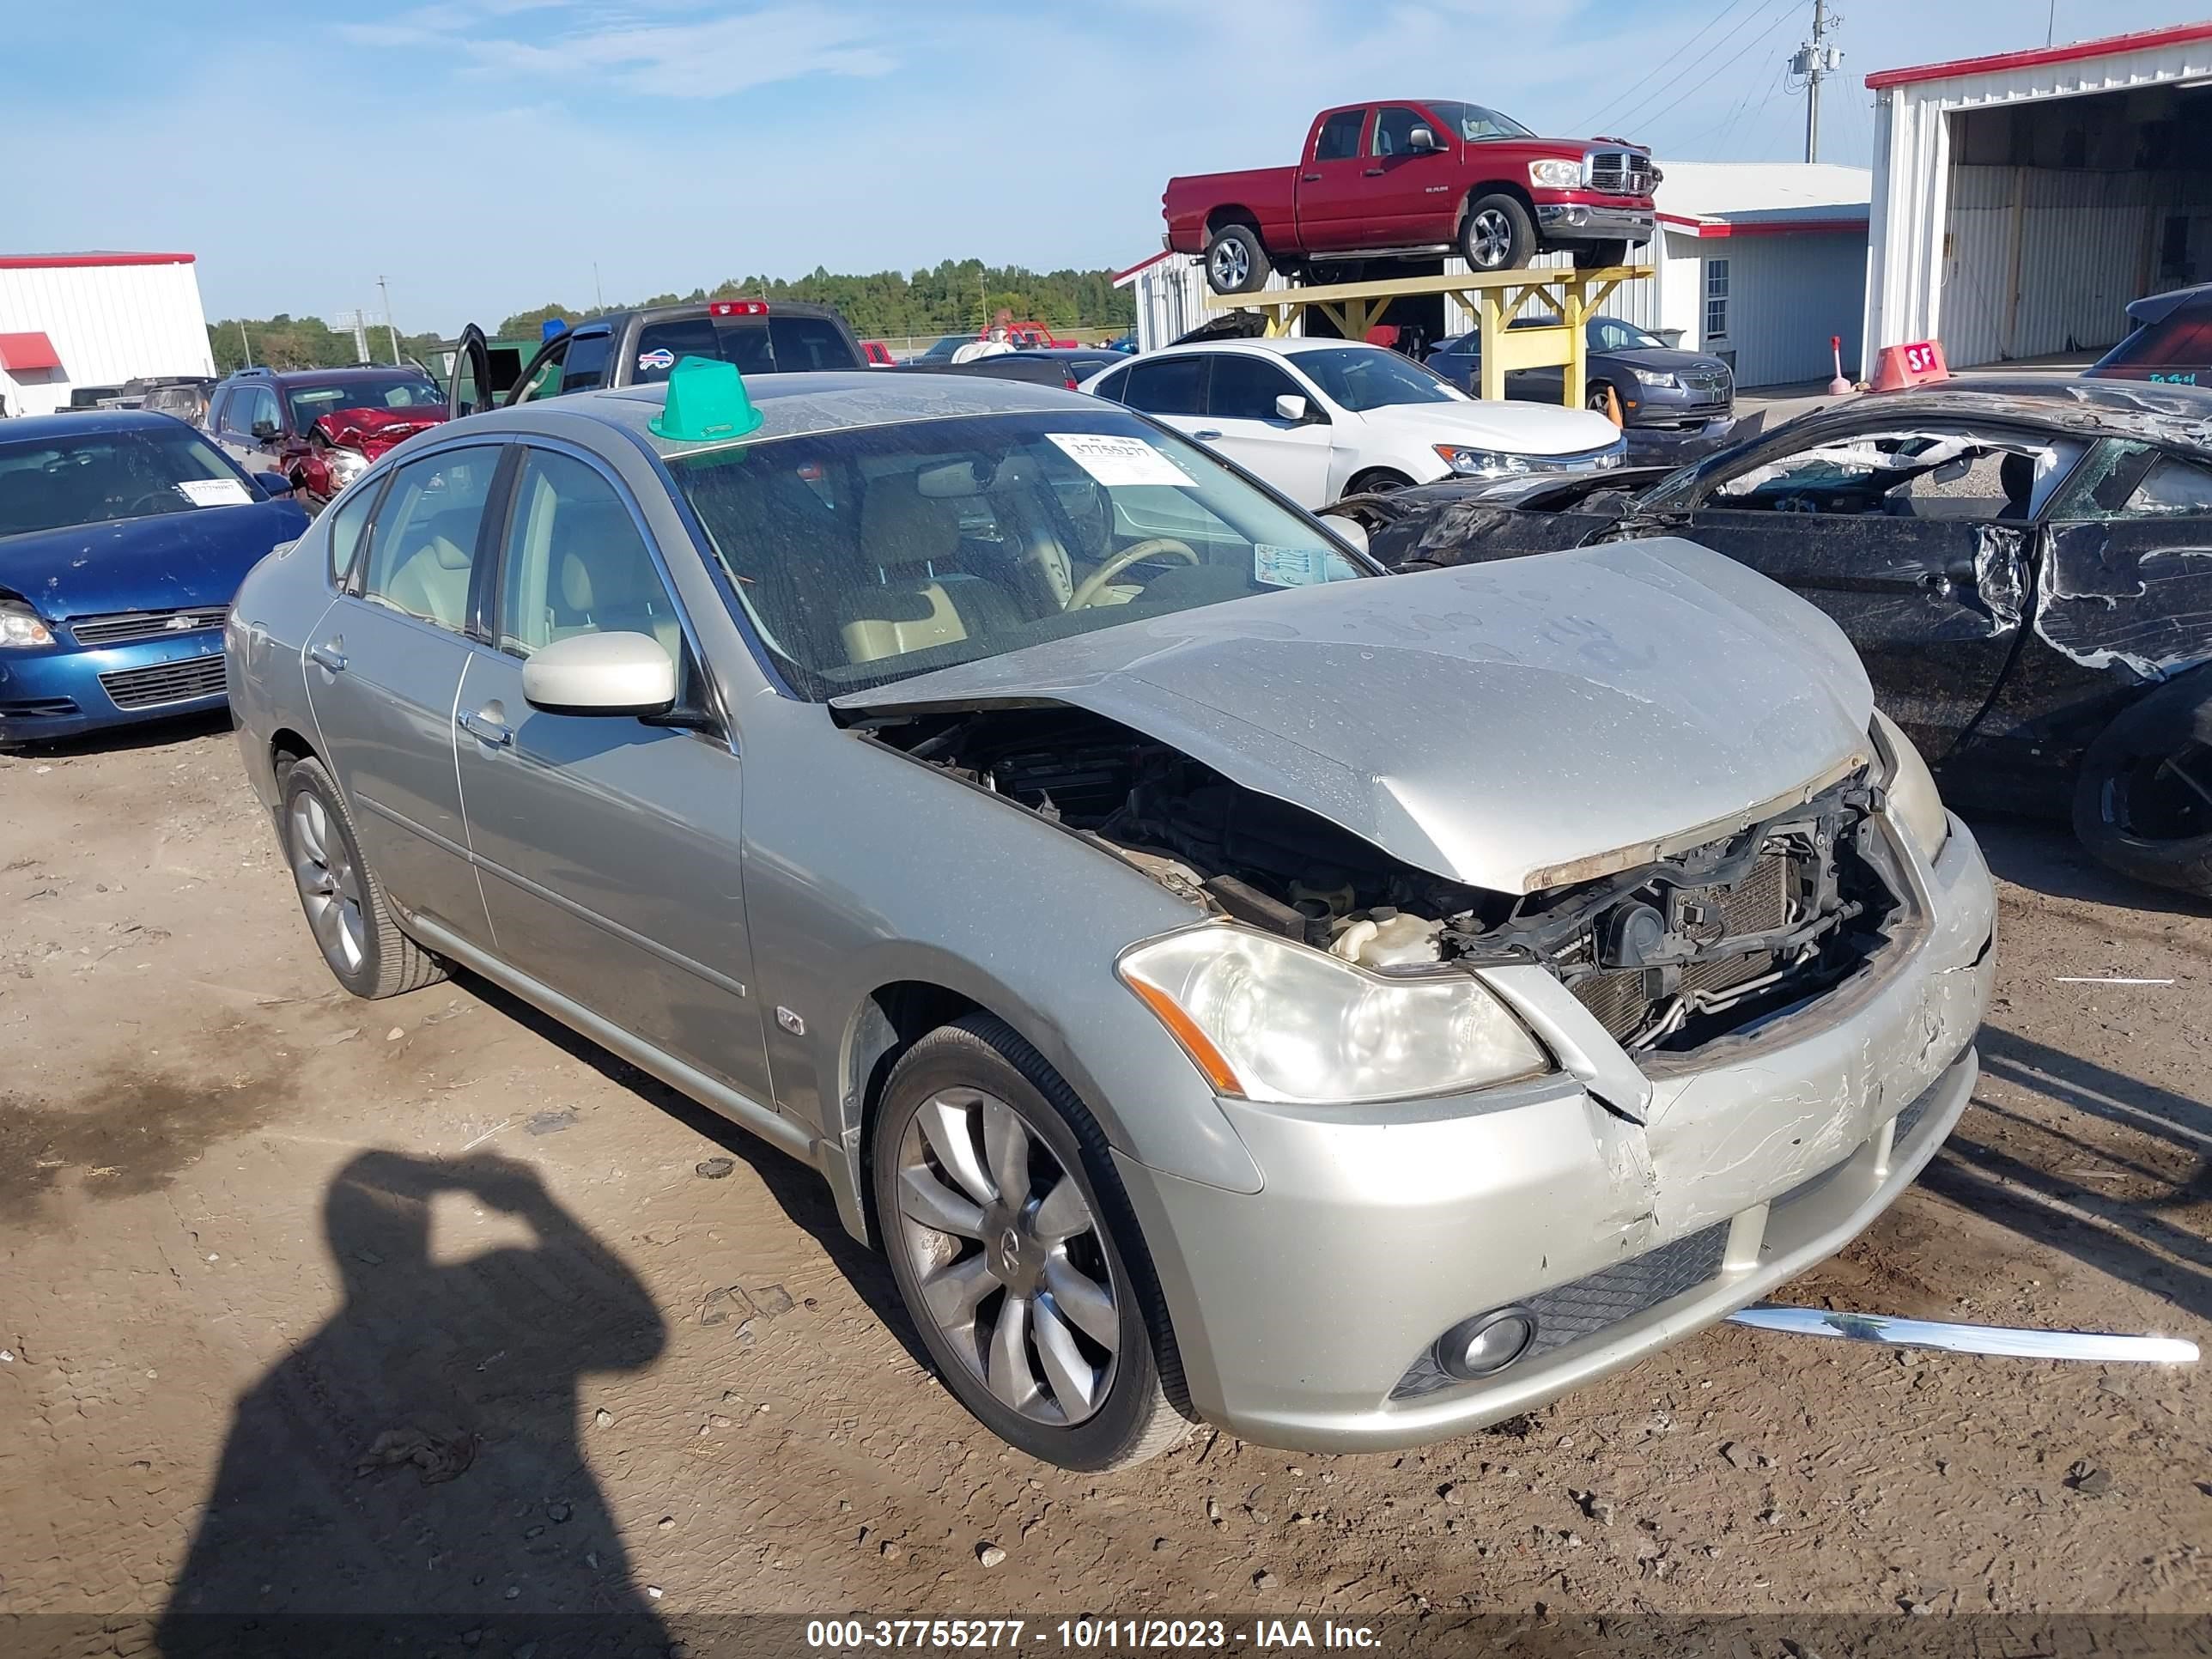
[305,445,504,942]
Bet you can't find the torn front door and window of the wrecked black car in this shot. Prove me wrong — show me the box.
[1683,428,2033,763]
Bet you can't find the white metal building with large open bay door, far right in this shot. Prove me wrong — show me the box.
[1865,22,2212,376]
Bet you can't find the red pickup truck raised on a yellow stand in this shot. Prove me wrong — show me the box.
[1159,97,1659,295]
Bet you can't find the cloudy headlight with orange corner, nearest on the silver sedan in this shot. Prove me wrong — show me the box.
[1115,925,1551,1103]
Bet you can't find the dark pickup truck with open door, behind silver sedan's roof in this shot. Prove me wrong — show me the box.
[447,299,867,416]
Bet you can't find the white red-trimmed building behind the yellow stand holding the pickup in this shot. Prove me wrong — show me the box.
[1115,161,1869,387]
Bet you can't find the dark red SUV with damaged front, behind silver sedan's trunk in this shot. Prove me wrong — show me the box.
[204,368,445,511]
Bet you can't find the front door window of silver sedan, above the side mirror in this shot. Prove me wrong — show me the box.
[498,449,684,661]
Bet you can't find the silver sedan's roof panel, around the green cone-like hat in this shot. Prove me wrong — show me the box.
[441,369,1097,456]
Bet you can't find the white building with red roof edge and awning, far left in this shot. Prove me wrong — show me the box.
[0,252,215,416]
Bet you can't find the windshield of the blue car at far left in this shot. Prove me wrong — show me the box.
[0,422,258,535]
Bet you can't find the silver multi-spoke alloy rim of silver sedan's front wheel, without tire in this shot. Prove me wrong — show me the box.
[898,1088,1124,1427]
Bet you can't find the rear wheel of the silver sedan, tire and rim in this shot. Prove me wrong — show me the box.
[279,759,445,1002]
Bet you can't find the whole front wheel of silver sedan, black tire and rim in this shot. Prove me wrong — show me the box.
[869,1015,1190,1471]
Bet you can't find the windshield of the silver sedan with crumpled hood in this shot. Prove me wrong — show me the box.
[668,410,1371,702]
